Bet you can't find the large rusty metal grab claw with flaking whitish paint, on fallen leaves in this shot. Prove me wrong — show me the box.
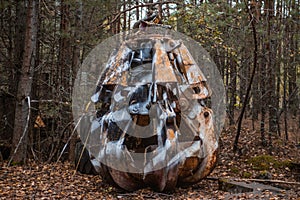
[82,34,218,191]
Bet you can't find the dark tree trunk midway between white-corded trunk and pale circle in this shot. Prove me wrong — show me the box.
[47,0,73,162]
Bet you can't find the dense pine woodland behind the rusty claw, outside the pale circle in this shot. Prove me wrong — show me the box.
[0,0,300,167]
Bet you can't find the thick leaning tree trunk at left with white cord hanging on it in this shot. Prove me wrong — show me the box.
[10,0,37,166]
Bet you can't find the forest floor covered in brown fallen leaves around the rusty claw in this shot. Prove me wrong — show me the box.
[0,122,300,199]
